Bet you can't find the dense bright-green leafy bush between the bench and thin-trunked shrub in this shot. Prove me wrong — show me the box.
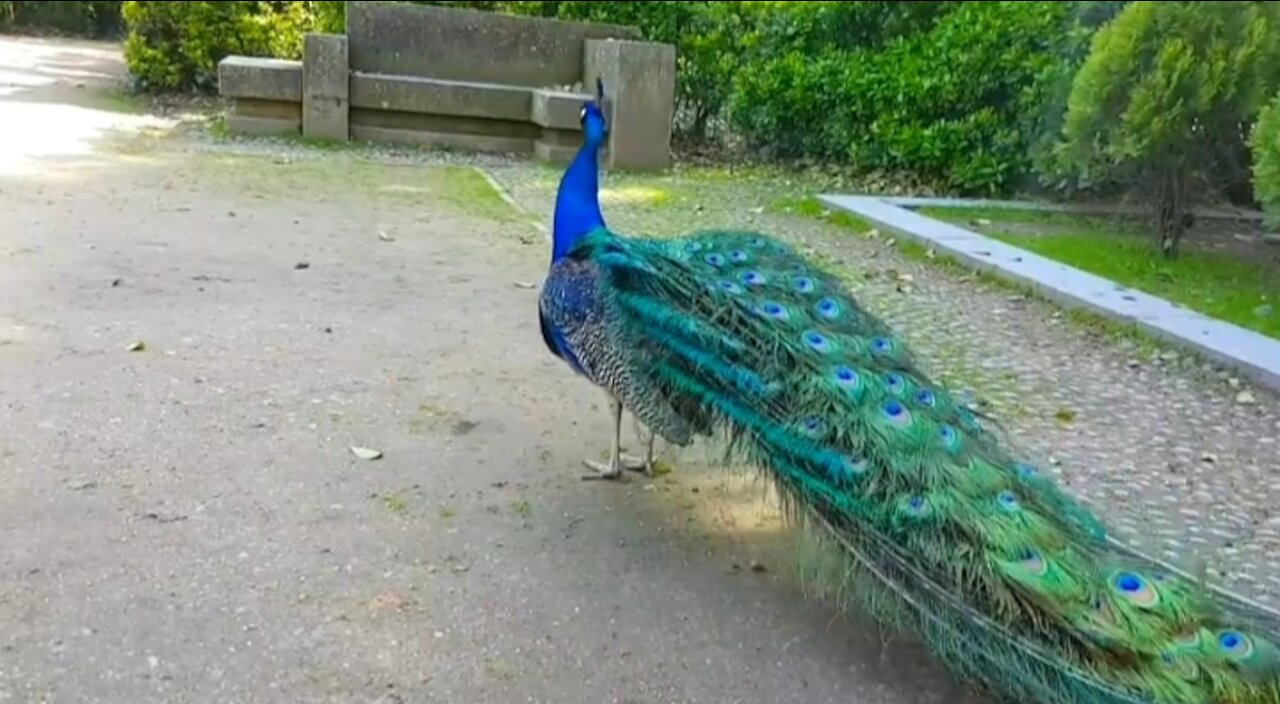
[731,1,1074,192]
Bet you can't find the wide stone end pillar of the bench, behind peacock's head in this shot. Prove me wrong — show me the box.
[582,40,676,170]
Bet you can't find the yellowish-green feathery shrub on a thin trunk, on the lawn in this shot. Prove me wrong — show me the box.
[1059,3,1280,256]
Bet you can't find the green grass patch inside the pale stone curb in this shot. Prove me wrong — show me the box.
[919,209,1280,339]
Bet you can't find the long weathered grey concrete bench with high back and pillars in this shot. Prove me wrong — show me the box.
[219,1,676,169]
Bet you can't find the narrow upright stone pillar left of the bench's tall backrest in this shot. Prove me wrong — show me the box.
[302,33,351,142]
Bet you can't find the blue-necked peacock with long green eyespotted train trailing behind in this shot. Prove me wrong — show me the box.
[538,81,1280,704]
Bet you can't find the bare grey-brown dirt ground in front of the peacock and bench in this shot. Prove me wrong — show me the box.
[0,40,988,704]
